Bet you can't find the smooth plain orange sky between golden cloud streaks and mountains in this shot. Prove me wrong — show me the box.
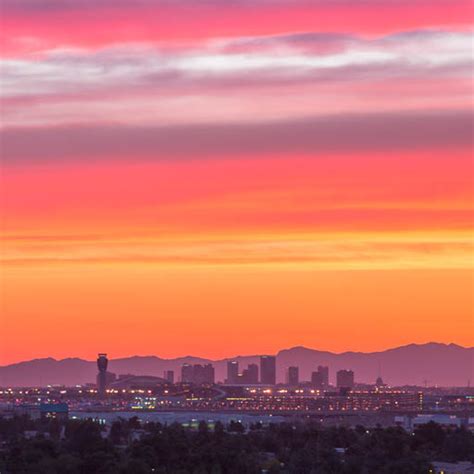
[1,263,473,362]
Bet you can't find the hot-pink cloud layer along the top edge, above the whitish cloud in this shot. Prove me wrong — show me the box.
[2,0,472,55]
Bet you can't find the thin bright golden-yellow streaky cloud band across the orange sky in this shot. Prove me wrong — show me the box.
[2,233,473,270]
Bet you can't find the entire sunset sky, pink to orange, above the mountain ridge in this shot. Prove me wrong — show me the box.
[0,0,474,364]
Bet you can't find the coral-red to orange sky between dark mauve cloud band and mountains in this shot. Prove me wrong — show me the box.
[0,152,473,363]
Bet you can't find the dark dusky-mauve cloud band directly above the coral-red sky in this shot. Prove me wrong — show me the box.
[0,111,473,162]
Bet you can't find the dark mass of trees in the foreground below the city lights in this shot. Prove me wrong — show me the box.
[0,417,474,474]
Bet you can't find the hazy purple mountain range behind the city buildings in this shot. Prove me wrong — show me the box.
[0,343,474,387]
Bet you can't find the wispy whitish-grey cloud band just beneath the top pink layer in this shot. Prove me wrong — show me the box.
[2,31,472,97]
